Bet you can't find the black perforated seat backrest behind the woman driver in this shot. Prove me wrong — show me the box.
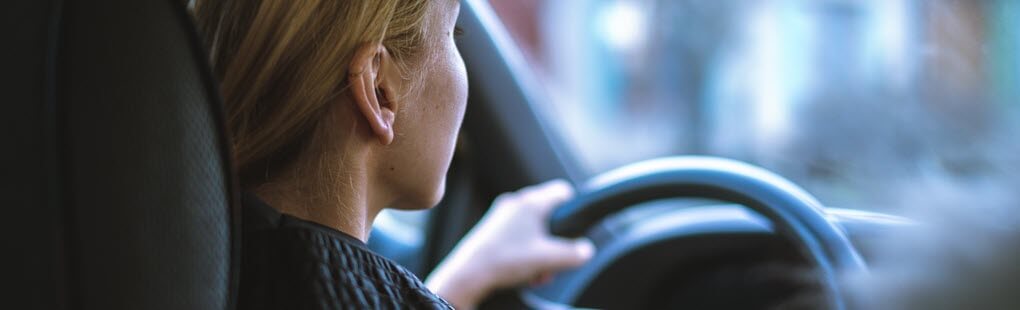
[0,0,240,309]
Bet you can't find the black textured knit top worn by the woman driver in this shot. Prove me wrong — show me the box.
[238,194,453,309]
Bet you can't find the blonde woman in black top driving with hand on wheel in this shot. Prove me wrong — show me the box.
[194,0,593,309]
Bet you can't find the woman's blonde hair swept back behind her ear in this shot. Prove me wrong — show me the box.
[193,0,432,188]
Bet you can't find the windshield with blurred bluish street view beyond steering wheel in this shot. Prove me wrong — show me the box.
[491,0,1020,208]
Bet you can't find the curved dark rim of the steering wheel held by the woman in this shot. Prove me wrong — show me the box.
[519,156,867,309]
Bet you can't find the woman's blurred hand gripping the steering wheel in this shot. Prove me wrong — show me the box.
[425,179,595,309]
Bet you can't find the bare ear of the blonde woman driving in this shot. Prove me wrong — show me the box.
[347,43,400,145]
